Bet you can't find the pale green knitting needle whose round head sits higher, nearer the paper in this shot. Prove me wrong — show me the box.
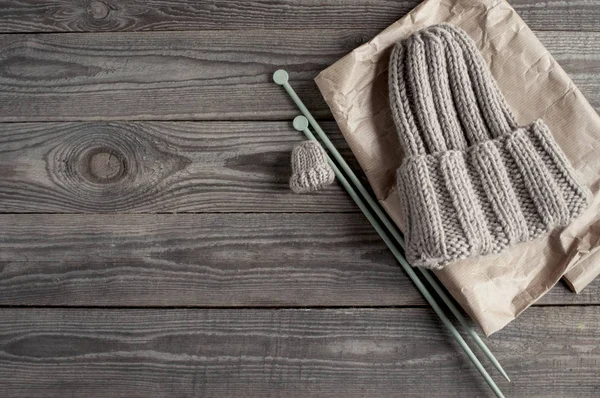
[273,69,510,382]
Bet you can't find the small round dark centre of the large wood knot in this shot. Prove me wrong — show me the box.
[82,147,127,184]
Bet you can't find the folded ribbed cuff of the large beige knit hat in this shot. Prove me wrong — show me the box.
[397,120,590,269]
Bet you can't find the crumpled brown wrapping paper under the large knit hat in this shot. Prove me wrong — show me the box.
[315,0,600,335]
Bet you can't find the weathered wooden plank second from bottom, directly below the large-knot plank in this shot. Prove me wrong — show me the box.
[0,213,600,307]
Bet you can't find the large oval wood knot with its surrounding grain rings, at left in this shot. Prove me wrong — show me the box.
[45,122,190,212]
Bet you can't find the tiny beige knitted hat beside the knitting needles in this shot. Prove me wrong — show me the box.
[290,141,335,193]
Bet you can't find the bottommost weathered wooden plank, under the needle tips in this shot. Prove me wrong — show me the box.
[0,307,600,398]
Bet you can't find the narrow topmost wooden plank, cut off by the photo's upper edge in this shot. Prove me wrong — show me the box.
[0,0,600,32]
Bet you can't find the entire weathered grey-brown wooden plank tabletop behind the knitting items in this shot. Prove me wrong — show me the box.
[0,0,600,398]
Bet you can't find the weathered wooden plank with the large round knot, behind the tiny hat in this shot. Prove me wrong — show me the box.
[0,122,359,213]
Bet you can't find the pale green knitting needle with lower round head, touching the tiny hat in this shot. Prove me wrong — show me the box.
[294,116,504,397]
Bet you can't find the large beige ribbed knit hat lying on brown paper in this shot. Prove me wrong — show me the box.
[389,24,590,269]
